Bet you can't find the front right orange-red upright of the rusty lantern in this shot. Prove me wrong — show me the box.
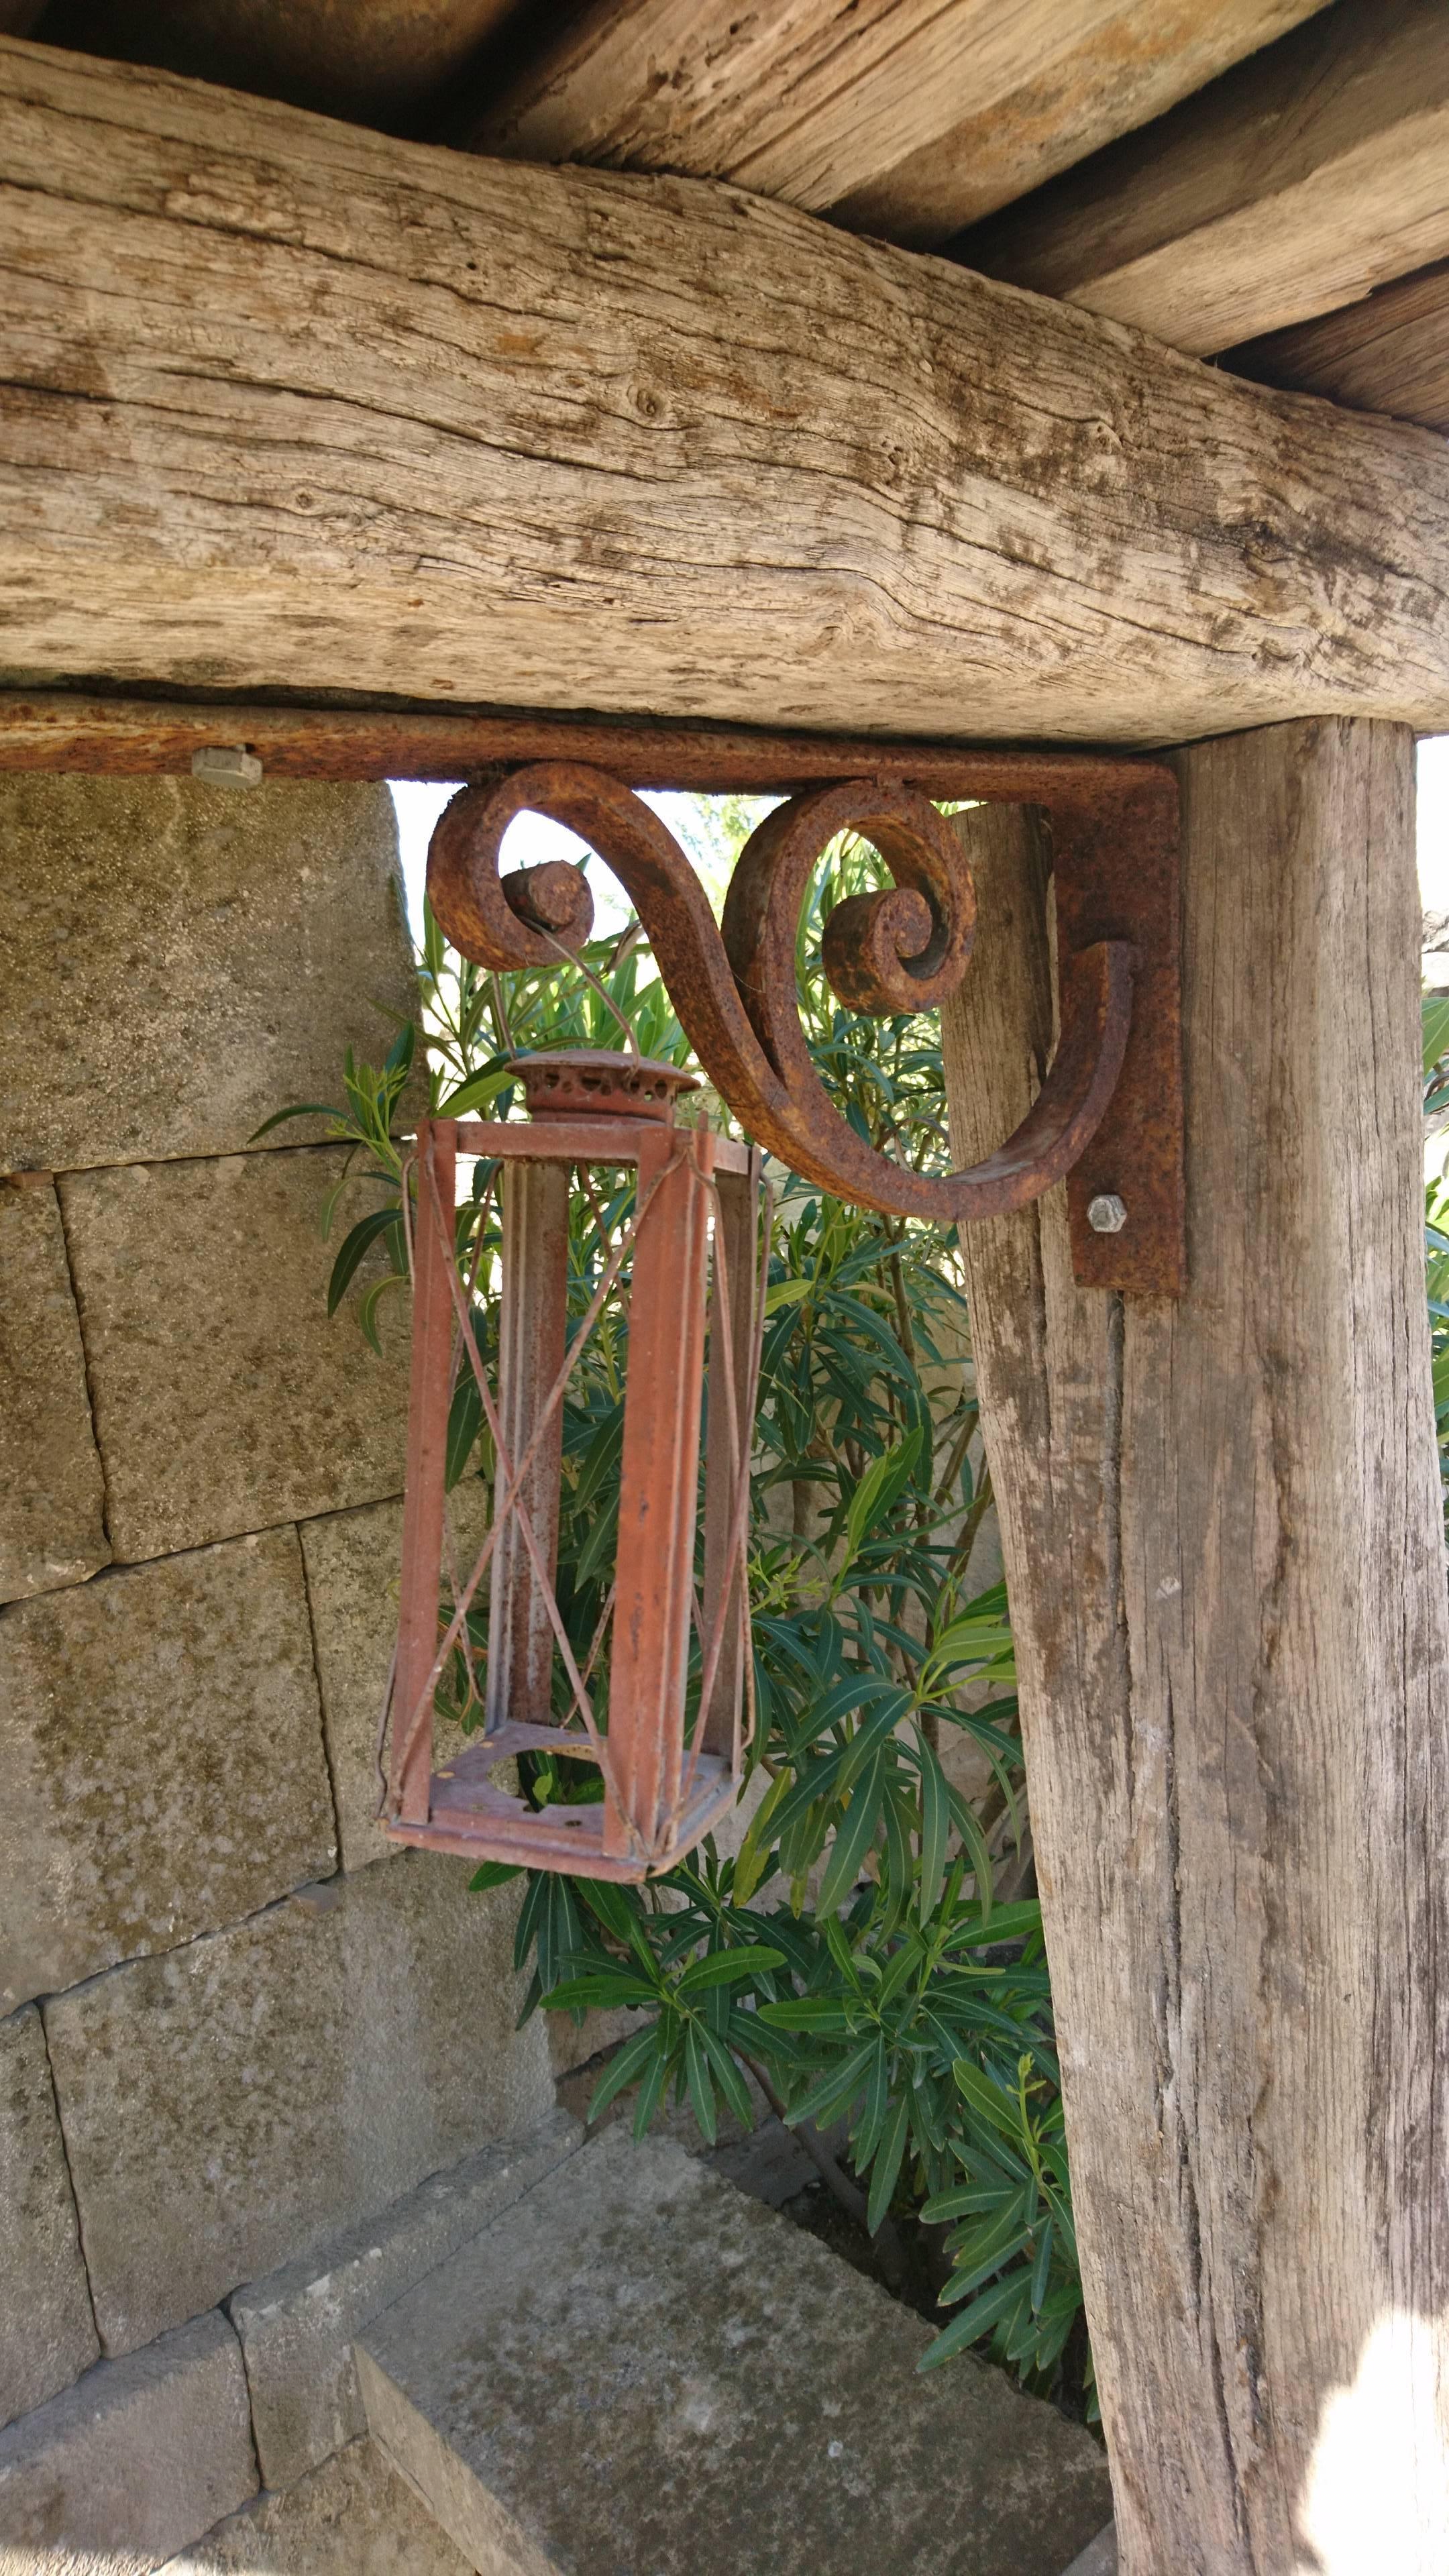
[603,1126,714,1852]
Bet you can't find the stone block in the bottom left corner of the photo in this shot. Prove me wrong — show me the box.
[0,2316,258,2576]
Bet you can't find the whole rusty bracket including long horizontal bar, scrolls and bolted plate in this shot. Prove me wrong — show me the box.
[0,690,1186,1296]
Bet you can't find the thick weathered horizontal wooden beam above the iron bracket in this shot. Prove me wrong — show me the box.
[0,44,1449,742]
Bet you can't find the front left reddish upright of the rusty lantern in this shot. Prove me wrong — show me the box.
[387,1118,456,1824]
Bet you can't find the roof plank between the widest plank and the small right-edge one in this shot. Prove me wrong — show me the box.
[954,0,1449,353]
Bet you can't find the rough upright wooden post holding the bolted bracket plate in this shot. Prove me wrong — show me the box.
[947,721,1449,2576]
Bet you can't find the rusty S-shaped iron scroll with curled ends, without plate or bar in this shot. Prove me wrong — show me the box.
[428,760,1134,1224]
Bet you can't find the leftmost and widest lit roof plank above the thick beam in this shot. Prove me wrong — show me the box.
[464,0,1323,248]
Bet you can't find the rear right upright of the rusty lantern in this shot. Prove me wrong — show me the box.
[701,1149,763,1760]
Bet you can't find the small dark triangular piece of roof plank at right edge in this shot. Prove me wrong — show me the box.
[1222,260,1449,430]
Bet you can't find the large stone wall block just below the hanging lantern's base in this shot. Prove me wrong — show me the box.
[44,1852,551,2352]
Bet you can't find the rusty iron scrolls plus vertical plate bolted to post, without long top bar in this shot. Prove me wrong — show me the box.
[428,752,1186,1296]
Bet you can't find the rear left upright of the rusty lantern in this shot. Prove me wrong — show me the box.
[485,1162,570,1733]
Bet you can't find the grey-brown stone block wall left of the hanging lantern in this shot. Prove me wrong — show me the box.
[0,778,551,2576]
